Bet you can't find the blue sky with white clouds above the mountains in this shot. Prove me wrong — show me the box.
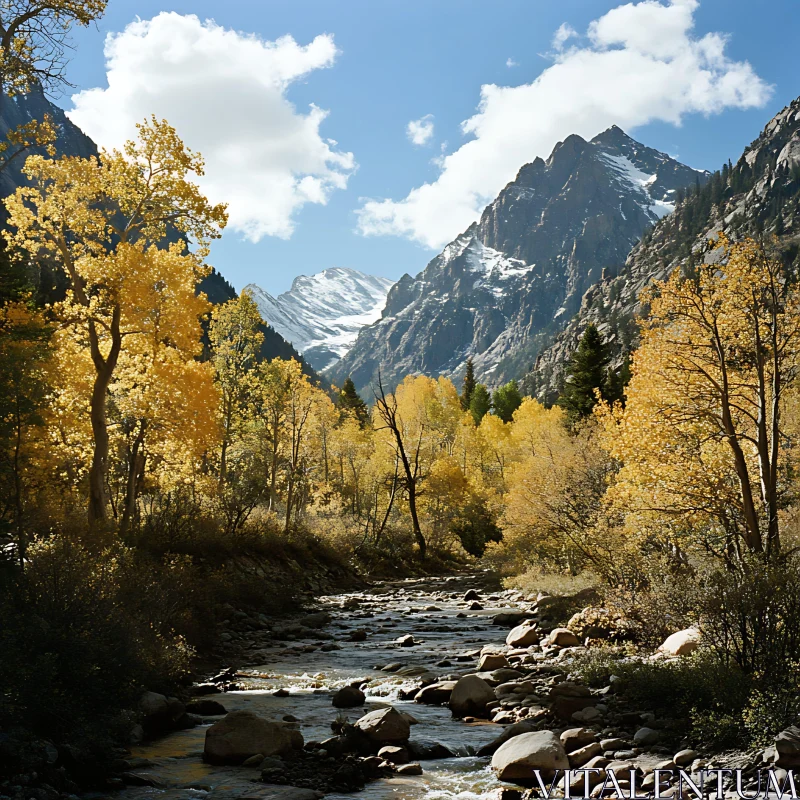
[57,0,800,294]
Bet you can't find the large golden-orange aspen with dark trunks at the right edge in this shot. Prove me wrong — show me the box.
[606,237,800,560]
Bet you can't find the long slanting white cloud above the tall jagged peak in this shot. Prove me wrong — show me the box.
[358,0,771,248]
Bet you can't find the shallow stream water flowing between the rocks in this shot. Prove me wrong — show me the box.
[117,576,523,800]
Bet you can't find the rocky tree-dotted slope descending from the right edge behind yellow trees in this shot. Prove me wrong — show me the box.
[523,98,800,400]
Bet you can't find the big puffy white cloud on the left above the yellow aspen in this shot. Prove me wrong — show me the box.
[69,12,355,242]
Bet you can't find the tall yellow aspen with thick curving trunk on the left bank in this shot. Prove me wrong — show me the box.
[6,118,227,523]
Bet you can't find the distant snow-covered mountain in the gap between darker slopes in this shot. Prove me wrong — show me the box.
[246,267,394,370]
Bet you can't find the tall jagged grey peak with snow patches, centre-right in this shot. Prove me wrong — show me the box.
[328,126,708,396]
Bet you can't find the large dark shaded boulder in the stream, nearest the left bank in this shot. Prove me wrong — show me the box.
[203,711,303,764]
